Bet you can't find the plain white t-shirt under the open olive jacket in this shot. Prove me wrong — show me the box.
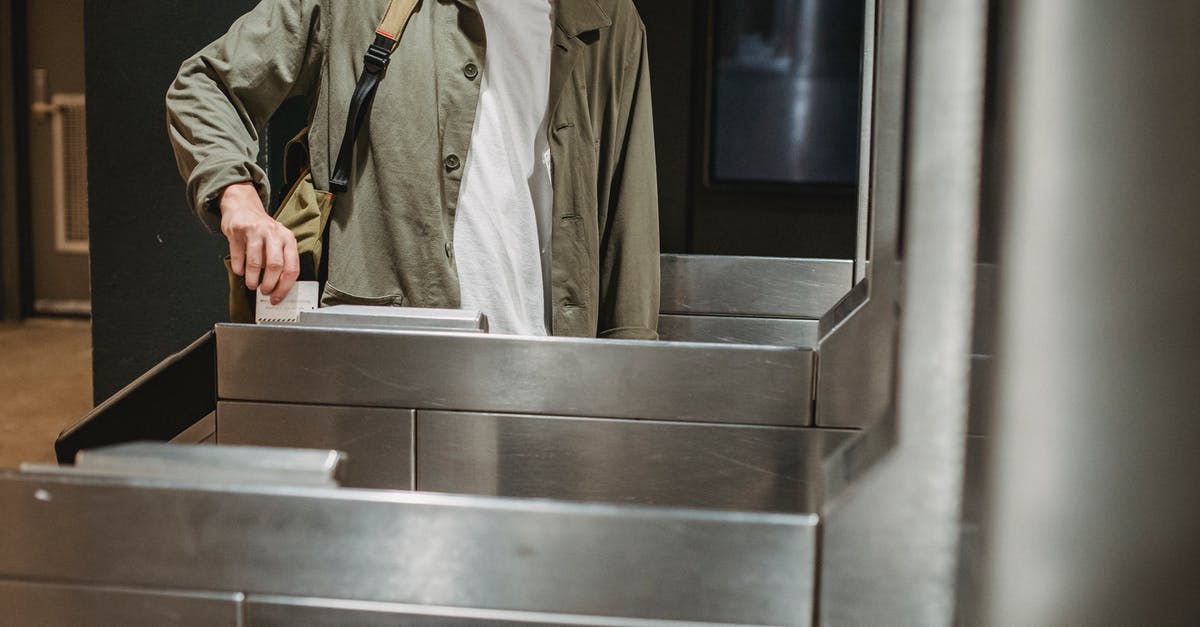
[454,0,553,335]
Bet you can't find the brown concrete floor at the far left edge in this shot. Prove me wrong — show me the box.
[0,318,91,468]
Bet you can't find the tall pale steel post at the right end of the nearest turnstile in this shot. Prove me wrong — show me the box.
[818,0,988,626]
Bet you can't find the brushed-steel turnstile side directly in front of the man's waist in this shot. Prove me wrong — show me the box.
[216,323,852,499]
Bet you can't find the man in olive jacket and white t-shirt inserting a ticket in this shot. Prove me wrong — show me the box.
[167,0,659,339]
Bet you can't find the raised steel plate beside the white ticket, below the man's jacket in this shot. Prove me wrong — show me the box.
[299,305,487,333]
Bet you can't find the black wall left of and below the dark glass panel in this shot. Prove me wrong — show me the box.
[634,0,858,258]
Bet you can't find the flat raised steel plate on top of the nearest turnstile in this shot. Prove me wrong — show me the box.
[36,442,342,486]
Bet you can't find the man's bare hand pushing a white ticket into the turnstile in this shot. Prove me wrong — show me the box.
[221,183,300,305]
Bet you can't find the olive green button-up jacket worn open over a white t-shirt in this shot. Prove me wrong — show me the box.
[167,0,659,339]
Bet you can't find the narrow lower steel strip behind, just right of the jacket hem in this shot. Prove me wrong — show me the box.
[659,315,817,347]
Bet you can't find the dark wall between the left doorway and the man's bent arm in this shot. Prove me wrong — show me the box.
[84,0,254,402]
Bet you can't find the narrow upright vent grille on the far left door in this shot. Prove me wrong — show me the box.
[50,94,88,253]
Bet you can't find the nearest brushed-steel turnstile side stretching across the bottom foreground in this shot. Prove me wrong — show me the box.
[0,444,817,627]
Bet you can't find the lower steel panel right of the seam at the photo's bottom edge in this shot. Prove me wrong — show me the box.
[246,596,728,627]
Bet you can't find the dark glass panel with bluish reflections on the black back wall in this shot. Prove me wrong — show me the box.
[710,0,864,185]
